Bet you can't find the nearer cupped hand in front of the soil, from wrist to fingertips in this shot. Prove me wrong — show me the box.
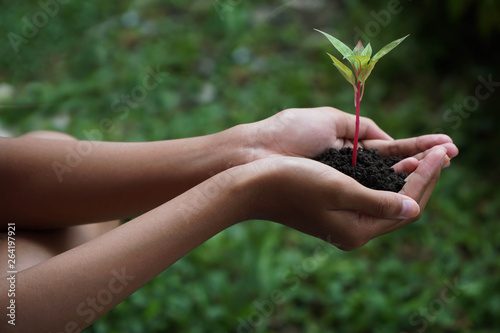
[238,147,447,250]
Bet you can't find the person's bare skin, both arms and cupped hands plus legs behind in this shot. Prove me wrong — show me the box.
[0,107,458,332]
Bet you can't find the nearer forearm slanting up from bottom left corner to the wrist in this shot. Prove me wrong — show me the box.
[0,170,248,332]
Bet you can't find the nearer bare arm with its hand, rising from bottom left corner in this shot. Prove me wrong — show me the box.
[0,143,446,332]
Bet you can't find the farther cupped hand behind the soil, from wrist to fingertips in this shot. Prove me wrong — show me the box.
[244,107,458,166]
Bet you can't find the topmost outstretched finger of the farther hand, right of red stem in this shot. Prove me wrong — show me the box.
[363,134,458,159]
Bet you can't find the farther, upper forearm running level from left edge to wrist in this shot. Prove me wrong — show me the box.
[0,126,251,228]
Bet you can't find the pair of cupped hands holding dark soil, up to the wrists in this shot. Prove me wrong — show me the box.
[229,107,458,250]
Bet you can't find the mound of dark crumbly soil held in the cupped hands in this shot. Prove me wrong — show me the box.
[316,148,408,192]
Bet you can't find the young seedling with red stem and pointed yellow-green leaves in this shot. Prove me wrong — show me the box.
[314,29,409,166]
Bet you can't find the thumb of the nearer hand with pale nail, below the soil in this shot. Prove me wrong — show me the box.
[349,187,420,219]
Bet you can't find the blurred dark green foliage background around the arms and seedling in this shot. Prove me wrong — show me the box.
[0,0,500,332]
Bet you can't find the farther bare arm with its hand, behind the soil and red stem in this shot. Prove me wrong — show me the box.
[0,107,458,228]
